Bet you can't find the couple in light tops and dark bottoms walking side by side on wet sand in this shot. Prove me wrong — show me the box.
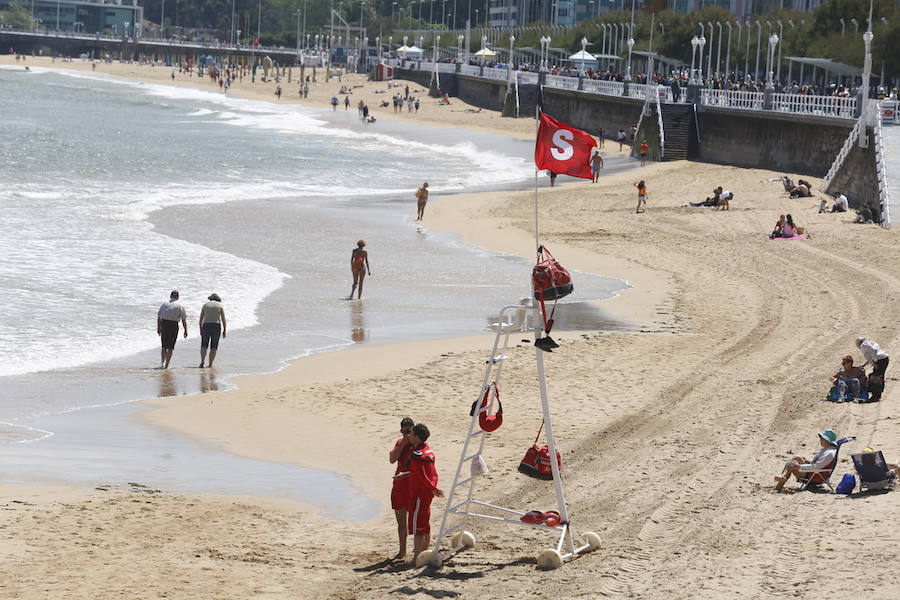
[156,290,227,369]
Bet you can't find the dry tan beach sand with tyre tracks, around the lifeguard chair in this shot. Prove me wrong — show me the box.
[0,57,900,600]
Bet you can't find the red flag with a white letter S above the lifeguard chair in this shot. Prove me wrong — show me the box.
[534,112,597,179]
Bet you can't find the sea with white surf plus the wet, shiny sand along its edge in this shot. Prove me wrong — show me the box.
[0,68,631,515]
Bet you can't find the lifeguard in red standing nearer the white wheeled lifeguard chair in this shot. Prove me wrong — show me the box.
[406,423,444,564]
